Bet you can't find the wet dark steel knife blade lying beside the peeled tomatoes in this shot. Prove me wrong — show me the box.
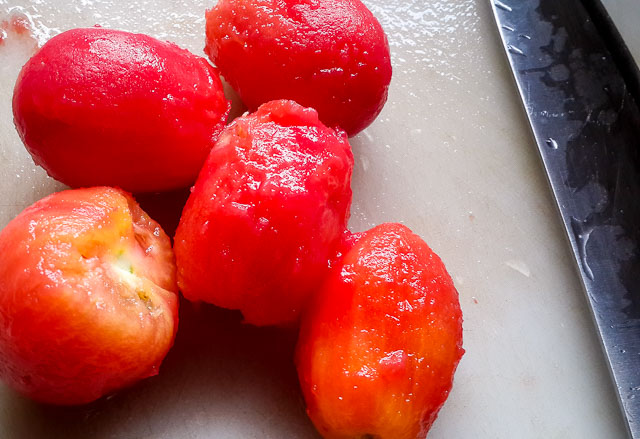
[492,0,640,439]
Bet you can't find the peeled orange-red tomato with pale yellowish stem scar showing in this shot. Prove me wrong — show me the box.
[0,187,178,405]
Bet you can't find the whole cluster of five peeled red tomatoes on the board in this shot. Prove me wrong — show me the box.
[0,0,463,438]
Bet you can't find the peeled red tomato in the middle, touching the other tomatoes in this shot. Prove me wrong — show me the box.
[175,101,353,326]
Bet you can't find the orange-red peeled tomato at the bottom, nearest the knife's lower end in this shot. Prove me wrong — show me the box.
[296,223,463,439]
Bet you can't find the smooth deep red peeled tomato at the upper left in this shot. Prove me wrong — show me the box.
[13,28,229,192]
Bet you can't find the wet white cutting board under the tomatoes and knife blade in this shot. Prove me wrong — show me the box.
[0,0,640,439]
